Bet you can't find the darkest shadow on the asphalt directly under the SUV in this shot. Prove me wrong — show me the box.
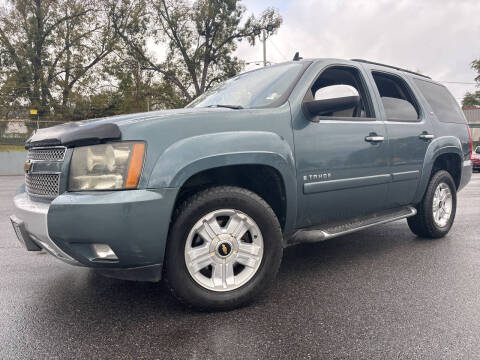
[34,222,438,315]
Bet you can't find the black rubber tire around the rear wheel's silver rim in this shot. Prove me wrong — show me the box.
[407,170,457,239]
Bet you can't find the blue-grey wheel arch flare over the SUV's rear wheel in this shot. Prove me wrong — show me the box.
[413,136,463,204]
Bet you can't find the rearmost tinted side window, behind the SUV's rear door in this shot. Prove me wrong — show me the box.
[414,79,466,124]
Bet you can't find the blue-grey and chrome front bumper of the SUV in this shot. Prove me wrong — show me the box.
[12,189,177,281]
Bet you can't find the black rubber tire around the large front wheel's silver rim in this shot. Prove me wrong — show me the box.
[164,186,283,310]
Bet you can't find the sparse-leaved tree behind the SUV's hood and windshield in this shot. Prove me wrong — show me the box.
[110,0,282,103]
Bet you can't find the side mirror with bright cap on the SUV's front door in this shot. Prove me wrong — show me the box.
[303,85,360,118]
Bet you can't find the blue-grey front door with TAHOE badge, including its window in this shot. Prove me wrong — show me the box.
[293,64,390,227]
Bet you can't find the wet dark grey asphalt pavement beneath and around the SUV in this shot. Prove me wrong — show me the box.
[0,174,480,359]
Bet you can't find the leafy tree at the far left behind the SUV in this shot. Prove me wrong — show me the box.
[0,0,116,124]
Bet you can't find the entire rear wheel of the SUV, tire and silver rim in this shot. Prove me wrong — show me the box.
[407,170,457,238]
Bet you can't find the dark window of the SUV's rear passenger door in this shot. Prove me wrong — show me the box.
[372,72,420,122]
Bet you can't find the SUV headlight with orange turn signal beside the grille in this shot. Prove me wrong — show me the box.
[68,142,145,191]
